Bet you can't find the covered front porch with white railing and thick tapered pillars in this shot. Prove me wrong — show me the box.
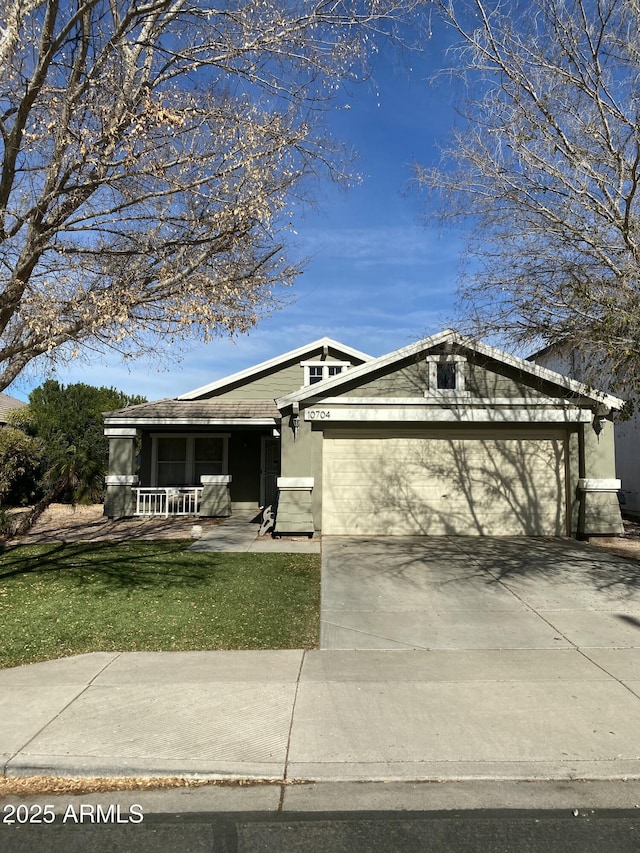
[104,399,280,519]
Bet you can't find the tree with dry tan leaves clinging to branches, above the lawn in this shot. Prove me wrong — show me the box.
[0,0,421,389]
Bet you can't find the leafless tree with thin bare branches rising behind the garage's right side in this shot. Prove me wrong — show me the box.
[418,0,640,384]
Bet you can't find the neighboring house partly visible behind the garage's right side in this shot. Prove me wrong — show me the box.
[528,344,640,518]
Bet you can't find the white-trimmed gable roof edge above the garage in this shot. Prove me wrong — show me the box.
[276,329,624,410]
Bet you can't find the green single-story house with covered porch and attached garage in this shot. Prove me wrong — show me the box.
[104,330,623,536]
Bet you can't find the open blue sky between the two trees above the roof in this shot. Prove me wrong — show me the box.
[7,23,462,399]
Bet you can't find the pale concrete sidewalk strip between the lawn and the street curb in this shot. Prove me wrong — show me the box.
[0,648,640,782]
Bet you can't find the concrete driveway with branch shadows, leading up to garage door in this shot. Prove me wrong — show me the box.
[320,536,640,648]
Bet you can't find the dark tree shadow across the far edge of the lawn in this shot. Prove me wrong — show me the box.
[0,541,228,591]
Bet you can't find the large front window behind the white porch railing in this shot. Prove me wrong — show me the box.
[152,435,228,486]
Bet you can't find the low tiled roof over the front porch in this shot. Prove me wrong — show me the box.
[104,397,280,426]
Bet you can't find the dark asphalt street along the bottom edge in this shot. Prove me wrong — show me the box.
[0,810,640,853]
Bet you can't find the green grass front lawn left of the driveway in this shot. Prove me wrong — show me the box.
[0,541,320,667]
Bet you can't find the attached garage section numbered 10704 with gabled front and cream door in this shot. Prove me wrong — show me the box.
[276,330,623,537]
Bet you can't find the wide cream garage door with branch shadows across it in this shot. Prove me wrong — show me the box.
[322,431,567,536]
